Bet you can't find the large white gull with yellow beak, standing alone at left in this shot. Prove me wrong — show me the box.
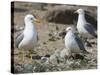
[15,14,40,61]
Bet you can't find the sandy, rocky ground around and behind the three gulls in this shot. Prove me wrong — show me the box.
[11,2,97,73]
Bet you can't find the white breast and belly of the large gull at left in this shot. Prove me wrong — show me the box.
[19,24,37,50]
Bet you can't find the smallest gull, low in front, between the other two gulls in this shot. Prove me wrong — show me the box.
[65,27,87,54]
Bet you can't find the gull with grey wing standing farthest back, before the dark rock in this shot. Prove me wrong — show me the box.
[75,9,97,38]
